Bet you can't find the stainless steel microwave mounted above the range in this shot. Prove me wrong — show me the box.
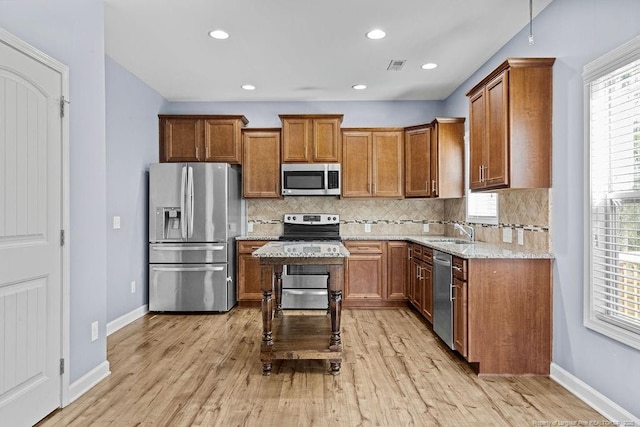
[281,163,340,196]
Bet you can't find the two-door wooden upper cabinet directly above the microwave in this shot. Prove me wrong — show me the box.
[280,114,342,163]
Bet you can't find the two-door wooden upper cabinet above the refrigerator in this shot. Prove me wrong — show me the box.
[158,115,248,164]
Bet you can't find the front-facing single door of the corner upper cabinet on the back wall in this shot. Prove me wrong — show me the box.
[405,127,431,197]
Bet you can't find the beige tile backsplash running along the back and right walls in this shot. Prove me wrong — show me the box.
[247,188,551,250]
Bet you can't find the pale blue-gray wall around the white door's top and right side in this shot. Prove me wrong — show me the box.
[0,0,107,382]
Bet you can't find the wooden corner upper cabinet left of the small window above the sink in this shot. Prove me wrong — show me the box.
[405,117,464,198]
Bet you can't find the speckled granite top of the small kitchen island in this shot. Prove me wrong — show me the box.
[251,241,349,258]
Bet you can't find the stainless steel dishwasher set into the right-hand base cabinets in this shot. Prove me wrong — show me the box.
[433,250,453,349]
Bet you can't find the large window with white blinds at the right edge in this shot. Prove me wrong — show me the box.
[583,37,640,349]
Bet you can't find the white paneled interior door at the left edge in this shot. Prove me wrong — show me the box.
[0,32,63,426]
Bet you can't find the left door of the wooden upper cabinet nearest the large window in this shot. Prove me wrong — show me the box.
[469,89,487,190]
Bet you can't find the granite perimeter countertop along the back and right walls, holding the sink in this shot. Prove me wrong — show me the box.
[236,235,554,259]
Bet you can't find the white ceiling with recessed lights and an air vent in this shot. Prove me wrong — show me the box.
[105,0,552,101]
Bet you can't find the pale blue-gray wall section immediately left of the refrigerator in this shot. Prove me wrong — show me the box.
[106,56,166,322]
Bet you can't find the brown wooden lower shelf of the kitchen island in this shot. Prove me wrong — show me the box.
[260,315,342,362]
